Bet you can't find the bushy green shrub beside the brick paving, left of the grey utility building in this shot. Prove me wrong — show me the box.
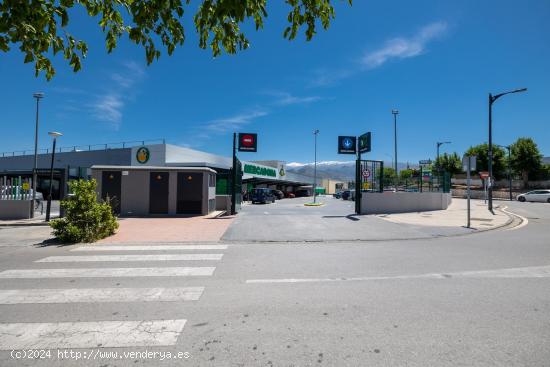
[50,180,118,243]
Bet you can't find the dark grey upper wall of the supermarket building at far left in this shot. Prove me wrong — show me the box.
[0,148,132,172]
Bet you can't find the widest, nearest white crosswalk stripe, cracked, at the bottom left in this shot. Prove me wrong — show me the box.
[0,320,186,350]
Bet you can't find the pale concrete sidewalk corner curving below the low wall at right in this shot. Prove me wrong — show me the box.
[377,198,511,231]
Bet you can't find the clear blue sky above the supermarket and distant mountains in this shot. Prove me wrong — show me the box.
[0,0,550,162]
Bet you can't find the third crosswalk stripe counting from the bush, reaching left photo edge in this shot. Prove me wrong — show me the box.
[0,267,216,279]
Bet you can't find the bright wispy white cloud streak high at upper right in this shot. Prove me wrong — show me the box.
[361,22,448,69]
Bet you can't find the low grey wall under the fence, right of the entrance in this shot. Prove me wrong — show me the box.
[361,192,452,214]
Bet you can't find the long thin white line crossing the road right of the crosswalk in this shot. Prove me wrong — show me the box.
[246,265,550,284]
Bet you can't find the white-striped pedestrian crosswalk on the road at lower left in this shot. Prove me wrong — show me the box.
[0,244,227,352]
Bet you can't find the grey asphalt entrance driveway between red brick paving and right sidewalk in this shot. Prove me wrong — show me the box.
[222,196,470,242]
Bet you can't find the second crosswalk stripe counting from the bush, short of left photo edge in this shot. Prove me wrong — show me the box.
[35,254,223,263]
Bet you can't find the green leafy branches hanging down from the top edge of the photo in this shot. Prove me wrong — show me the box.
[0,0,352,80]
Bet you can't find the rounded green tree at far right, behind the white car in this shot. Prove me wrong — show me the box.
[511,138,542,187]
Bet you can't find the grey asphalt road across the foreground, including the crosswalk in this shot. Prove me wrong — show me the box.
[0,203,550,366]
